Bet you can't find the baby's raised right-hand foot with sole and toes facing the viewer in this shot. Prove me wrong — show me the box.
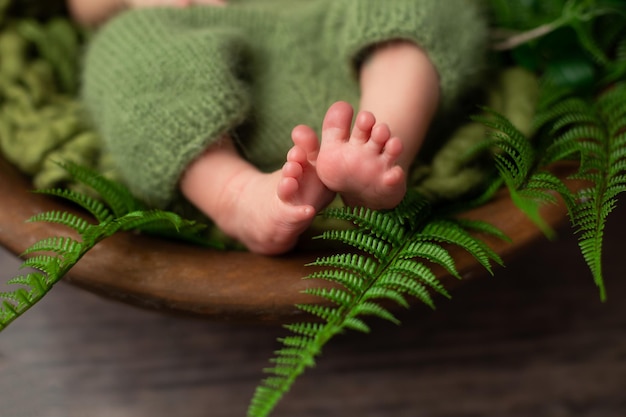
[316,102,406,209]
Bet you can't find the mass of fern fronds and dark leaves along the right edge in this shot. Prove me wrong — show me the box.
[476,0,626,300]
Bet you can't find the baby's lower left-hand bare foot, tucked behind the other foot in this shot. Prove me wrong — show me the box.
[211,126,334,255]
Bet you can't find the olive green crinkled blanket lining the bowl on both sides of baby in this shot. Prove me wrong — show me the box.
[0,0,538,206]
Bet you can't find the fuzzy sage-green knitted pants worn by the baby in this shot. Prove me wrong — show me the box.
[83,0,486,207]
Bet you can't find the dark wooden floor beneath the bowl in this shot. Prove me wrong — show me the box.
[0,203,626,417]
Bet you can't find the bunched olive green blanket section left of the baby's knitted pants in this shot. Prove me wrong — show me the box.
[0,2,116,188]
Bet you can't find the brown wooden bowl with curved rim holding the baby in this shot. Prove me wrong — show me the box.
[0,153,573,322]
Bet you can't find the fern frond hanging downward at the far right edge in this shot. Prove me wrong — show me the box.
[540,83,626,300]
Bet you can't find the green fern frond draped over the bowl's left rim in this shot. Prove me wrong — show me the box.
[0,164,209,331]
